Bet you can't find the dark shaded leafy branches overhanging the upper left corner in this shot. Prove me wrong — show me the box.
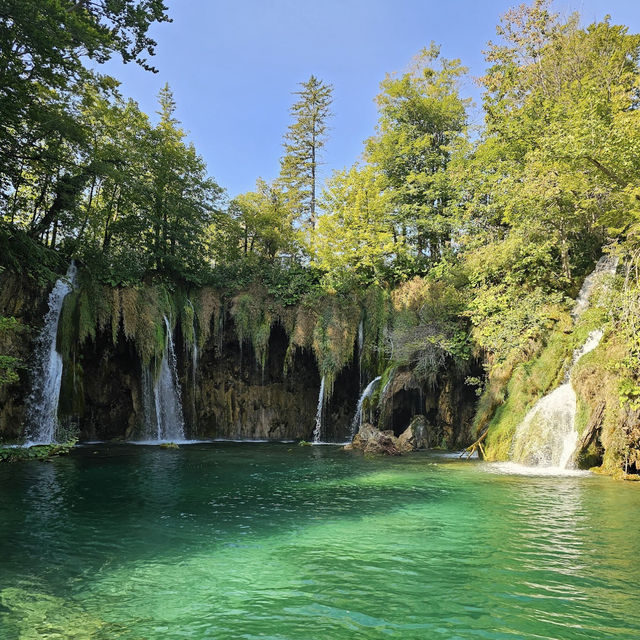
[0,0,169,196]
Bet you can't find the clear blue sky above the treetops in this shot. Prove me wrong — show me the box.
[96,0,640,196]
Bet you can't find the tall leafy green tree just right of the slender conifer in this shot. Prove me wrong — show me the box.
[365,43,469,270]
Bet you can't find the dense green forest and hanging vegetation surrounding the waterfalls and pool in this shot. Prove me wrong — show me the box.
[0,0,640,471]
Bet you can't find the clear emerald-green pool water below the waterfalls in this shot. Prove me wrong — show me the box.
[0,444,640,640]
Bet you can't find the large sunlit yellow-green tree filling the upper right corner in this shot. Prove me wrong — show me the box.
[476,0,640,283]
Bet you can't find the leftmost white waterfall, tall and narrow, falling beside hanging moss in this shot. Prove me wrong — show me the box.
[26,260,77,444]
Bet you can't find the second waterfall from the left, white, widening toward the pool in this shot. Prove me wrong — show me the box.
[142,316,185,442]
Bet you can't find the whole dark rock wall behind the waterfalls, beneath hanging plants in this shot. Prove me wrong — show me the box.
[0,274,475,444]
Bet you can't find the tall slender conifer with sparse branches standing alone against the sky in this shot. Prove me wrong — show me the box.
[280,75,333,229]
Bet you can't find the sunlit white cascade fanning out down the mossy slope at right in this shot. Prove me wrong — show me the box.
[510,256,618,470]
